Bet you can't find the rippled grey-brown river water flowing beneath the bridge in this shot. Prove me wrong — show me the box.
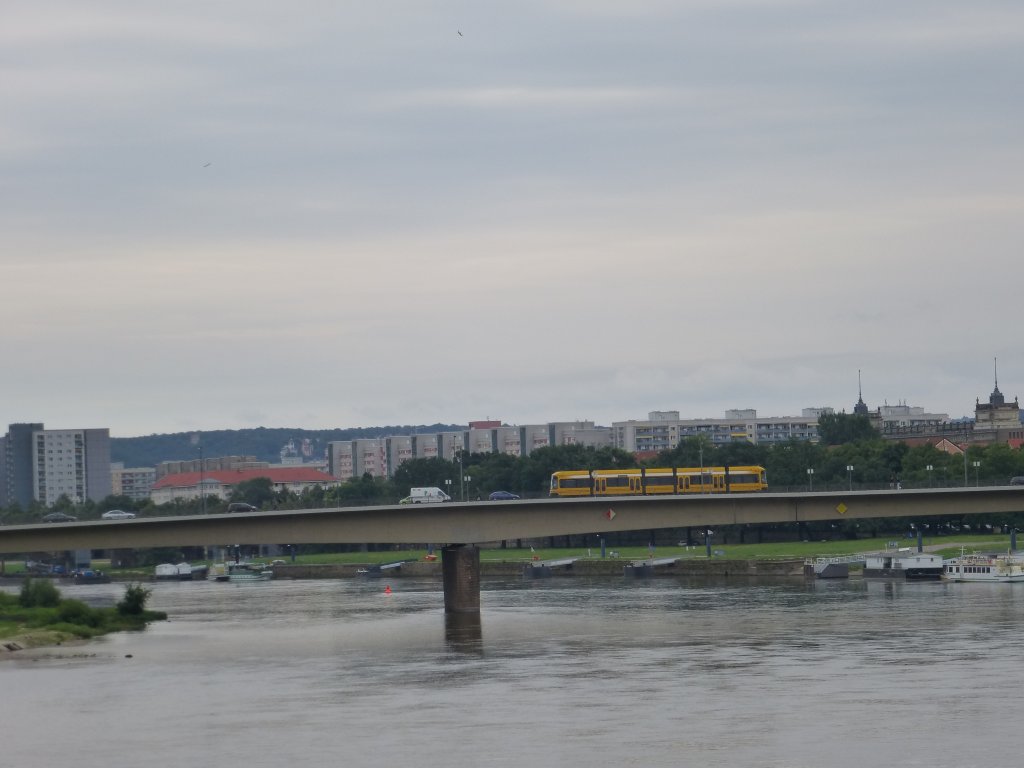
[0,578,1024,768]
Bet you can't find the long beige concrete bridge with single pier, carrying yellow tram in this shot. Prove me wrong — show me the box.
[0,485,1024,612]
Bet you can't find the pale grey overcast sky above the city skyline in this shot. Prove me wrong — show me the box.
[0,0,1024,436]
